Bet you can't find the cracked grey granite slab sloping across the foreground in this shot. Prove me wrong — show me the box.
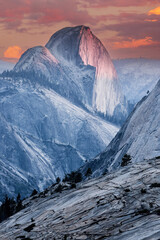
[0,158,160,240]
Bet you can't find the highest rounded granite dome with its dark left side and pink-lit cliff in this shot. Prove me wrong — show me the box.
[46,26,126,119]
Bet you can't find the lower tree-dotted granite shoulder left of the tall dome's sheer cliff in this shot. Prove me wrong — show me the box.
[14,46,95,109]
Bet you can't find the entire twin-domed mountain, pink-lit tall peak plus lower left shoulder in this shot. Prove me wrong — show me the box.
[14,26,128,123]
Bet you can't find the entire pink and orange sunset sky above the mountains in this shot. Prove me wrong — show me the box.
[0,0,160,61]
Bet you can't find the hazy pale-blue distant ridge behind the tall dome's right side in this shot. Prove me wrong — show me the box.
[113,58,160,103]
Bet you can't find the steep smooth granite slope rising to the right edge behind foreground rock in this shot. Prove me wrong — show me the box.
[83,80,160,176]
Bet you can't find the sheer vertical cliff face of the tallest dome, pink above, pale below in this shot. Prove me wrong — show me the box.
[79,27,121,116]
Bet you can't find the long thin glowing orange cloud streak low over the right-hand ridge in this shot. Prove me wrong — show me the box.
[113,37,155,49]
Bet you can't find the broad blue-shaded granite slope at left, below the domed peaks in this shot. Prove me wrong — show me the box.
[0,78,118,199]
